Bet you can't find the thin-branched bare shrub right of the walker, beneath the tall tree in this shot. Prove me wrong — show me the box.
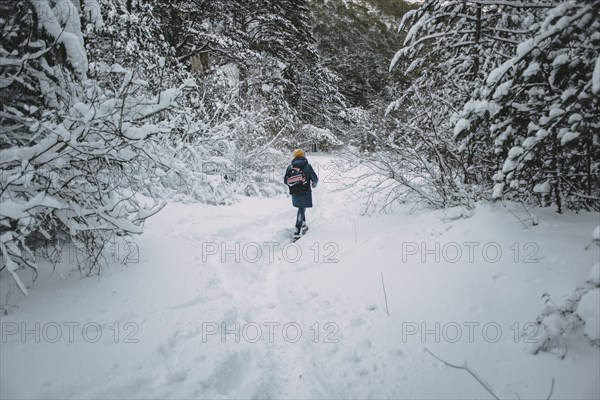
[370,86,480,212]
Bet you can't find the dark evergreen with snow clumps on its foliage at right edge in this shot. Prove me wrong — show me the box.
[456,1,600,212]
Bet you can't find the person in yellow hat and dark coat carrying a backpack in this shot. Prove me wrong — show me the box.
[283,149,319,240]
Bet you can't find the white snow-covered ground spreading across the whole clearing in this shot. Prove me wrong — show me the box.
[0,155,600,399]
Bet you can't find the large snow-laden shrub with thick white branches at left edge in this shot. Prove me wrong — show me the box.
[0,0,185,294]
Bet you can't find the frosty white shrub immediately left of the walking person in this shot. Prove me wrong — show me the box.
[139,65,292,204]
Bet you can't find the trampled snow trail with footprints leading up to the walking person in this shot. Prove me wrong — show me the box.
[119,155,360,398]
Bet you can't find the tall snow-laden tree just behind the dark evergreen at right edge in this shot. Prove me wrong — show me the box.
[388,0,593,208]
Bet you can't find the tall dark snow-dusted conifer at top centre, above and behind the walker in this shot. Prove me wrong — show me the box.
[155,0,335,141]
